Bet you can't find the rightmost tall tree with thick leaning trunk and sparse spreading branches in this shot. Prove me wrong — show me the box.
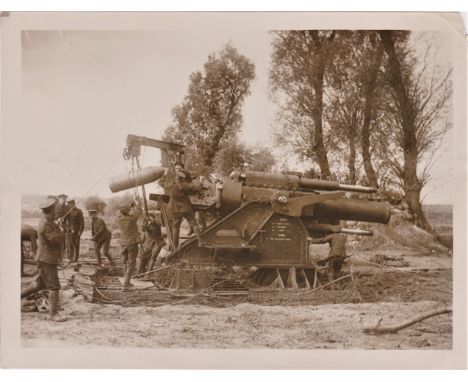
[379,31,452,231]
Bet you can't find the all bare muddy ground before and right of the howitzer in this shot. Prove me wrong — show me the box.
[21,203,452,349]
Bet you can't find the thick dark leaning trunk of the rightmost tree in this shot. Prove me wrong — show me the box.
[379,31,433,232]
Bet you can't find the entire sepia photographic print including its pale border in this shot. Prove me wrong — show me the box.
[1,13,466,368]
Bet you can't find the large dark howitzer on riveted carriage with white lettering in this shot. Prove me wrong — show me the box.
[110,137,390,289]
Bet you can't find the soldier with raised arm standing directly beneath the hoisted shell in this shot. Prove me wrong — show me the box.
[118,202,142,292]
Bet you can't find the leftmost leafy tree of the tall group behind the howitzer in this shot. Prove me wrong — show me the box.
[270,31,336,178]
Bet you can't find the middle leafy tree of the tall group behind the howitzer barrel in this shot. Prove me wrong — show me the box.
[325,31,383,187]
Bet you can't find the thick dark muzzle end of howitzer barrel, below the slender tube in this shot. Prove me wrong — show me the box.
[302,199,391,224]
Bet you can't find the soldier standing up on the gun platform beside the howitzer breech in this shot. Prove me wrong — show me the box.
[167,162,203,248]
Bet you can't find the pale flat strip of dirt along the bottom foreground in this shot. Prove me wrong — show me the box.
[22,300,452,349]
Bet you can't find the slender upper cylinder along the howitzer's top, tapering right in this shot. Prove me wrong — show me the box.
[238,171,377,193]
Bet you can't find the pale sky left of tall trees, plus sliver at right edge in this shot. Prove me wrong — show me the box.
[19,30,452,203]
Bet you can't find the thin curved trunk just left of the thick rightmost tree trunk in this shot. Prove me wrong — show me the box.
[361,40,383,188]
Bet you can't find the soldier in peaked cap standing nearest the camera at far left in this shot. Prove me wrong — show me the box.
[21,199,66,322]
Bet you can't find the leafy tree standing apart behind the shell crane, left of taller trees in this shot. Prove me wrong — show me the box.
[164,44,255,169]
